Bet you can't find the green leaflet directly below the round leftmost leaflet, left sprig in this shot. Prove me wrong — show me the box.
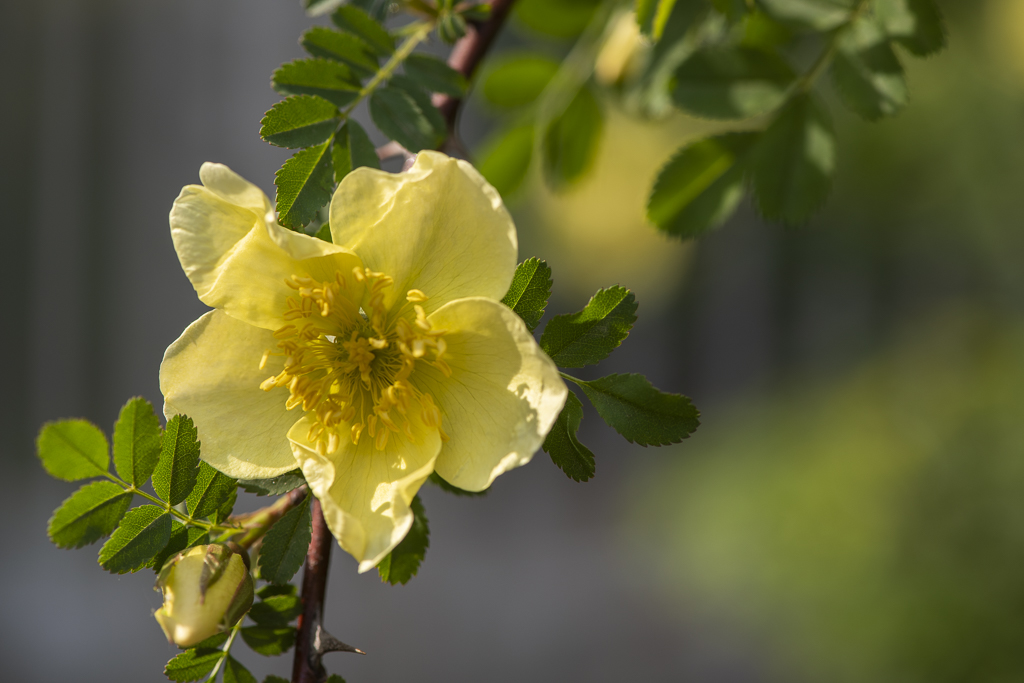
[46,481,132,548]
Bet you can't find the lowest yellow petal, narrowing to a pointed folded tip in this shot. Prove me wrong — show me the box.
[288,401,441,572]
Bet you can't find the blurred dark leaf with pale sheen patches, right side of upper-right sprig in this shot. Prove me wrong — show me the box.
[833,17,909,121]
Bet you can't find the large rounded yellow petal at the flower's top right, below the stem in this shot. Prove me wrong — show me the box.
[331,152,518,312]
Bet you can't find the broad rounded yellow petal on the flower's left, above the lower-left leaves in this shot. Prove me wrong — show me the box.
[160,310,301,479]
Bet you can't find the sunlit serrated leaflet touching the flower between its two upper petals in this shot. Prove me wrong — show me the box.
[273,140,334,228]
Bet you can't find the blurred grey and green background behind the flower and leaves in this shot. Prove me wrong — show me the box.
[0,0,1024,683]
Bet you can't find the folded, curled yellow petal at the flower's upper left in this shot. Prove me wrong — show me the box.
[170,164,361,330]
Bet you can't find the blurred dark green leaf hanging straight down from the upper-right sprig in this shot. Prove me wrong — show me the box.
[751,94,836,223]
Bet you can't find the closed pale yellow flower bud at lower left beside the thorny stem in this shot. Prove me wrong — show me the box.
[154,544,253,647]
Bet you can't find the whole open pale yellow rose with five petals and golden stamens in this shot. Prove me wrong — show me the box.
[160,152,567,571]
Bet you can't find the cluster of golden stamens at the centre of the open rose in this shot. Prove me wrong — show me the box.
[260,268,452,455]
